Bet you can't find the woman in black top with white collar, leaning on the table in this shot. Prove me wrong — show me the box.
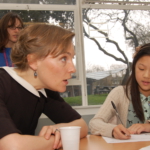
[0,24,87,150]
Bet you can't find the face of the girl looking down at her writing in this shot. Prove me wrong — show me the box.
[135,56,150,96]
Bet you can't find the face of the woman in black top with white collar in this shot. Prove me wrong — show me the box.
[34,43,76,92]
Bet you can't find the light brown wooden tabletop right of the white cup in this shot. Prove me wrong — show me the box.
[79,135,150,150]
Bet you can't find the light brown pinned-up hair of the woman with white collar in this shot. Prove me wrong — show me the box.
[11,24,75,71]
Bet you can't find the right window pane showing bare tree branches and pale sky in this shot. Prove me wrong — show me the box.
[82,8,150,105]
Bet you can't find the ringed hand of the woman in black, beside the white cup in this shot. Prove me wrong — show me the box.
[39,126,62,149]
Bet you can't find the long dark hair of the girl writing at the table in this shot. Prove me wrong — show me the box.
[125,43,150,122]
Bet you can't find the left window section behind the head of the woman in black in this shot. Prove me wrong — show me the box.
[0,4,82,106]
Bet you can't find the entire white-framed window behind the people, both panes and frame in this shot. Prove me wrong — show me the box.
[0,0,150,113]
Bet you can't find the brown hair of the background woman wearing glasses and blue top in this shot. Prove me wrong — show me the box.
[0,12,24,52]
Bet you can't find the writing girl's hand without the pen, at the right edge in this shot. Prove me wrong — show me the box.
[128,123,150,134]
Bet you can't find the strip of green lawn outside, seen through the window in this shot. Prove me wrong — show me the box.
[64,94,108,106]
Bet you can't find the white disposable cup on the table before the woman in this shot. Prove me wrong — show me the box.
[59,126,81,150]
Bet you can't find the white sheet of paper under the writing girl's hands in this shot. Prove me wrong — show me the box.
[103,134,150,143]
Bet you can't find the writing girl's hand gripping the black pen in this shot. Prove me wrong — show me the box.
[112,124,131,140]
